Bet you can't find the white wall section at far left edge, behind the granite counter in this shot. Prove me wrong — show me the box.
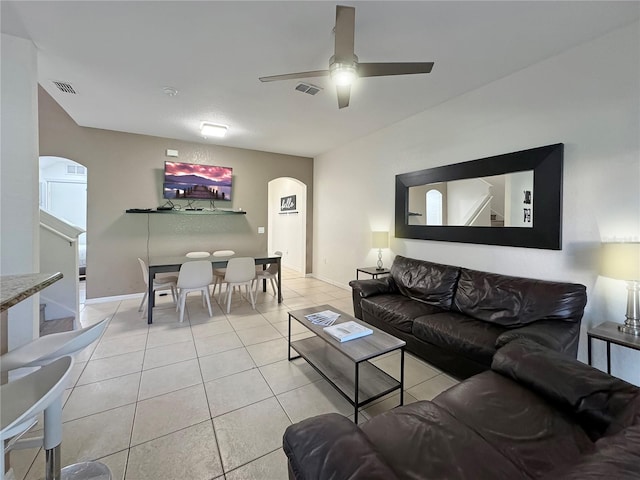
[0,34,40,349]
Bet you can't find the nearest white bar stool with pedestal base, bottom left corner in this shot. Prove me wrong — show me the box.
[0,356,111,480]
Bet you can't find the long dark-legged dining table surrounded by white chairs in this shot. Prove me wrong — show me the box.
[147,252,282,324]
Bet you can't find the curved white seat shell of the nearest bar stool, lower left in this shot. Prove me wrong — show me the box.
[0,356,73,442]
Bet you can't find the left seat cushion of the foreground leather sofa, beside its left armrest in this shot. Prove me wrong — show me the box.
[360,399,530,480]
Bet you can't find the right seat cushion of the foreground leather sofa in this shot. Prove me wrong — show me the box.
[433,371,595,478]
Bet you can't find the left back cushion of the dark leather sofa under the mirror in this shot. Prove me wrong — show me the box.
[391,255,460,310]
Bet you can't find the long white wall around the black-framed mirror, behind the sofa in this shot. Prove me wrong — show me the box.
[313,22,640,384]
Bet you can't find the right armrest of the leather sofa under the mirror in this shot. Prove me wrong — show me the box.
[495,320,580,358]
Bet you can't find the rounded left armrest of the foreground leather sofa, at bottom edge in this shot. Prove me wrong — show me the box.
[283,413,397,480]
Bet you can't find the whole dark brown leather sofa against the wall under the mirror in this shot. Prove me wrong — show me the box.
[349,255,587,378]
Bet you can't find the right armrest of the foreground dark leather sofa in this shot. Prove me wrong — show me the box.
[491,339,640,440]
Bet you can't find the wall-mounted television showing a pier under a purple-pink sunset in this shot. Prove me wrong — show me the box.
[162,162,233,202]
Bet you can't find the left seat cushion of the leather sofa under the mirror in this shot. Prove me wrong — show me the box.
[360,294,442,333]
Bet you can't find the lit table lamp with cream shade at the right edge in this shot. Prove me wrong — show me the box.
[600,242,640,336]
